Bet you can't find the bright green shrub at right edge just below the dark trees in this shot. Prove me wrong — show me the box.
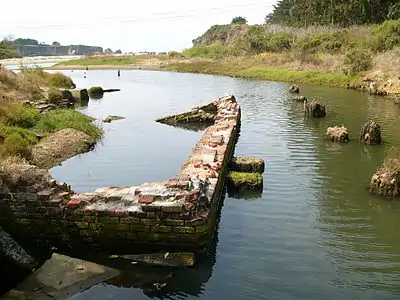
[371,20,400,52]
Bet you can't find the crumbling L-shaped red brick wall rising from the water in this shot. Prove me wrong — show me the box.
[0,96,240,252]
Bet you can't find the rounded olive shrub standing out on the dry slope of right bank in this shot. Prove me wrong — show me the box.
[344,48,372,75]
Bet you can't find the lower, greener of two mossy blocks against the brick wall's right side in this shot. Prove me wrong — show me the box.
[227,171,263,191]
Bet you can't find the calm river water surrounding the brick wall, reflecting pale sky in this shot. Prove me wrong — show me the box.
[46,71,400,300]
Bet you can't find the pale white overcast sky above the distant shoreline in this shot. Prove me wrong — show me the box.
[0,0,276,52]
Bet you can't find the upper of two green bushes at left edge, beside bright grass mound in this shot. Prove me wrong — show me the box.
[0,103,40,128]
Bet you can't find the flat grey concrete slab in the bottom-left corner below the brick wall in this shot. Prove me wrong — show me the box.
[2,253,120,300]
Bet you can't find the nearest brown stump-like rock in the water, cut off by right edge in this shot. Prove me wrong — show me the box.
[369,158,400,199]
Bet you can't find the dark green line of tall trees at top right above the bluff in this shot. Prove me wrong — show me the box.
[265,0,400,27]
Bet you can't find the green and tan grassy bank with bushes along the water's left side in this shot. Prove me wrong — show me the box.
[0,68,102,160]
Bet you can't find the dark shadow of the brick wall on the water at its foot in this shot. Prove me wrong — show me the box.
[67,188,226,299]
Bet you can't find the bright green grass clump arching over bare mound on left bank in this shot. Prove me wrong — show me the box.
[36,109,103,141]
